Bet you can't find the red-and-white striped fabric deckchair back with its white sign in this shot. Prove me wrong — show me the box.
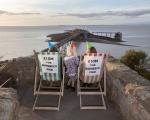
[83,53,105,83]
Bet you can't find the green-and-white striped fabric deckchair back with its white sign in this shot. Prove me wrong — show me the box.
[38,52,61,81]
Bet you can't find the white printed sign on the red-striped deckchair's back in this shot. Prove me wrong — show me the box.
[84,56,104,76]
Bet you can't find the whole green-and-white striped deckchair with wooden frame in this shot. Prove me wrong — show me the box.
[33,50,65,111]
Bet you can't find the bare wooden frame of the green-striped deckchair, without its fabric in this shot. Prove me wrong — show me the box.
[33,50,65,111]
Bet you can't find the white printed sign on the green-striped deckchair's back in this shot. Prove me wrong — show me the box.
[38,54,58,73]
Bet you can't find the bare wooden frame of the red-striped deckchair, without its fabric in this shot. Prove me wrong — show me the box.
[77,53,107,110]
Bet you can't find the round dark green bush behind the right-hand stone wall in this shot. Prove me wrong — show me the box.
[120,49,147,70]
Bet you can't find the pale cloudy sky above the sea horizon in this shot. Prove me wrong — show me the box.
[0,0,150,26]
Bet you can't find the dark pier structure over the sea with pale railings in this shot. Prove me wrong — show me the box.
[47,29,123,49]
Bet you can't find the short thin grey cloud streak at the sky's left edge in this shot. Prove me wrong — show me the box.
[0,10,40,15]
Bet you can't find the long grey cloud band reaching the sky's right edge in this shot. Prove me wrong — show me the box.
[57,9,150,18]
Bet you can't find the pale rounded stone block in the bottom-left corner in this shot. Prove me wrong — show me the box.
[0,88,19,120]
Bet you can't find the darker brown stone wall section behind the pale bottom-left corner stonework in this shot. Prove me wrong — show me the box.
[0,56,35,104]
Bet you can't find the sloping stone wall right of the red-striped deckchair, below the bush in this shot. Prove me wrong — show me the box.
[107,58,150,120]
